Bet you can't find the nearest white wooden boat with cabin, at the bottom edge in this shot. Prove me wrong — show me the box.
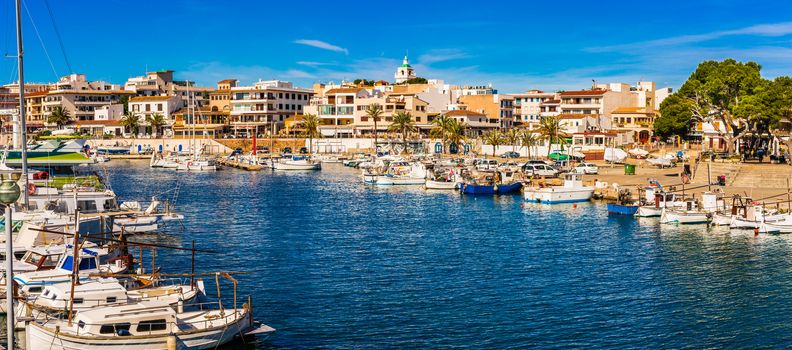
[26,301,266,350]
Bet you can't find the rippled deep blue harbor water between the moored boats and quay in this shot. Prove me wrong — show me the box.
[96,160,792,349]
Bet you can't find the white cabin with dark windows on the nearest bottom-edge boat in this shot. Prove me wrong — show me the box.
[75,302,179,337]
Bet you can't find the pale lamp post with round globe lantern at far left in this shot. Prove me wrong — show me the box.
[0,176,20,349]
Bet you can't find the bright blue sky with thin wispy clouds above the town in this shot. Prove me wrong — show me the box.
[0,0,792,93]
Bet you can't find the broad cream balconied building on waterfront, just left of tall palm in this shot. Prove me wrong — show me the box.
[229,80,314,136]
